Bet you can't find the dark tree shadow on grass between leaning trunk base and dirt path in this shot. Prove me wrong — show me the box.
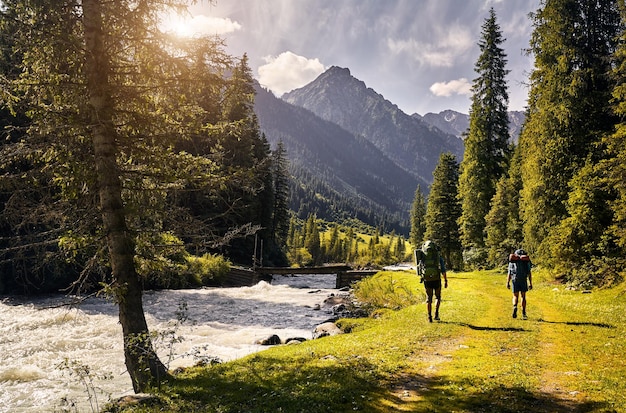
[155,355,388,413]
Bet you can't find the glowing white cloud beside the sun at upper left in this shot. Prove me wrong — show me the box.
[162,14,241,37]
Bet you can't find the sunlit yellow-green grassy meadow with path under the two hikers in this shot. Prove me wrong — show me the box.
[110,271,626,413]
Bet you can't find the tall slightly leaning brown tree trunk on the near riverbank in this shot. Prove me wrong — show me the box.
[82,0,167,393]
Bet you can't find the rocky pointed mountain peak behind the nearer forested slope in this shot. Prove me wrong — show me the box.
[282,66,464,182]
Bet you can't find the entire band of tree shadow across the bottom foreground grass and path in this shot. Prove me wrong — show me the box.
[141,356,608,413]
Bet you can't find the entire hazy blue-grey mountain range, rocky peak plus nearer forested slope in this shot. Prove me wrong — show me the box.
[255,67,521,235]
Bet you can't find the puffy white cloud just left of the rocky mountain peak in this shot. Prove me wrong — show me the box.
[258,51,325,96]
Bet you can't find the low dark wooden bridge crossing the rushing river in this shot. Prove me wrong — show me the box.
[224,265,378,288]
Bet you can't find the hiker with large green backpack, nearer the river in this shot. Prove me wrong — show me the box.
[415,240,448,323]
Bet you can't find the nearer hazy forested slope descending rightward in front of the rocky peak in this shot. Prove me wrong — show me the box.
[255,82,428,233]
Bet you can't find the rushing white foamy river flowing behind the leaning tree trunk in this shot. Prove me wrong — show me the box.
[0,275,338,413]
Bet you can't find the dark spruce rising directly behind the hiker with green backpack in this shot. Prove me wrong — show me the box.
[424,153,461,268]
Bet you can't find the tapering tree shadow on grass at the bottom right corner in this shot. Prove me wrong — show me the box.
[393,375,612,413]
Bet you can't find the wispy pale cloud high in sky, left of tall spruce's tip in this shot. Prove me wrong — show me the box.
[387,25,474,67]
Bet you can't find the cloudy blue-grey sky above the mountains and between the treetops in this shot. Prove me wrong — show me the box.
[167,0,540,115]
